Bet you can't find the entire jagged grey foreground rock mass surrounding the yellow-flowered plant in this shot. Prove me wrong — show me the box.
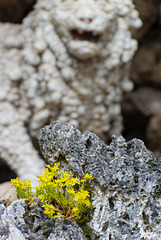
[0,121,161,240]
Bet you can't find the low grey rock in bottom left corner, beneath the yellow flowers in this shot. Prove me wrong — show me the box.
[0,200,85,240]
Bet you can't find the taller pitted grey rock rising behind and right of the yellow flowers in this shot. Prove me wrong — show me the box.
[39,121,161,240]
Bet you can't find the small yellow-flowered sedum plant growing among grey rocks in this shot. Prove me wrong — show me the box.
[11,163,93,222]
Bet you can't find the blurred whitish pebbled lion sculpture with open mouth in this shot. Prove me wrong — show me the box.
[0,0,140,183]
